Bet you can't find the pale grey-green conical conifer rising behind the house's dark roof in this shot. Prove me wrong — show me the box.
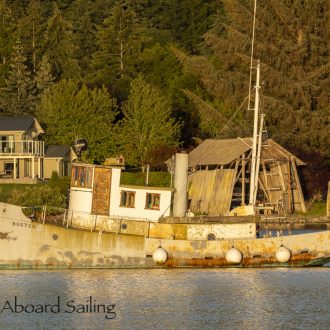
[0,39,36,116]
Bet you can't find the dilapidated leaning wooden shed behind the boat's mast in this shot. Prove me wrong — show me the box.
[188,138,306,215]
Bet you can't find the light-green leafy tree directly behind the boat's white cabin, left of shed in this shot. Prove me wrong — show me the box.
[122,75,180,167]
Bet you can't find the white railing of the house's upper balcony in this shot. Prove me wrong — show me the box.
[0,140,45,156]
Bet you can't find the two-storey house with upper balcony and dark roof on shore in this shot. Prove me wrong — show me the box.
[0,117,77,183]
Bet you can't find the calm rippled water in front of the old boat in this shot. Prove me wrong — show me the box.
[0,267,330,329]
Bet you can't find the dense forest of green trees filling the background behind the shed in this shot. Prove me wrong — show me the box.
[0,0,330,195]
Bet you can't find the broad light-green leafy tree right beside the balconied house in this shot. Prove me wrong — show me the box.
[38,80,117,163]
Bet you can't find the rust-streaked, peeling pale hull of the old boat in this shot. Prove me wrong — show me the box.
[0,203,330,269]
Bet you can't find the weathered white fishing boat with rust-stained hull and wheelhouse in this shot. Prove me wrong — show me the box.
[0,146,330,269]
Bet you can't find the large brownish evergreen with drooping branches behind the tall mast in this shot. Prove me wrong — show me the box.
[177,0,330,159]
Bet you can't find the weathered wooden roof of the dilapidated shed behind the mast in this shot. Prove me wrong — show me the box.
[189,138,305,167]
